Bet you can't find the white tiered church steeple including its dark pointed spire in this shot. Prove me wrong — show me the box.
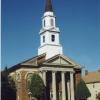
[38,0,63,59]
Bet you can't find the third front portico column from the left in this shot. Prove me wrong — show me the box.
[61,72,66,100]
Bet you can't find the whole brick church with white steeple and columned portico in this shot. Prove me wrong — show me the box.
[9,0,81,100]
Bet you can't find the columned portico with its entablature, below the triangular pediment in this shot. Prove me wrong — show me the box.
[40,67,74,100]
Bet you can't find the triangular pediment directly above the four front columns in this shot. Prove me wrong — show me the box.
[43,54,79,67]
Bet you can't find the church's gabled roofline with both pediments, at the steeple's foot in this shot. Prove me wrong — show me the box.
[9,53,80,72]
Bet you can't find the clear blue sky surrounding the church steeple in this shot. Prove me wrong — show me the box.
[1,0,100,71]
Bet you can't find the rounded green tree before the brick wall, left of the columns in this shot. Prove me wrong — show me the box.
[29,74,45,99]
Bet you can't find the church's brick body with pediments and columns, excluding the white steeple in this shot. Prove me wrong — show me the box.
[10,54,81,100]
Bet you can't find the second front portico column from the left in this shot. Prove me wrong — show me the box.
[52,72,57,100]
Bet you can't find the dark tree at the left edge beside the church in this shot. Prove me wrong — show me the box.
[1,67,16,100]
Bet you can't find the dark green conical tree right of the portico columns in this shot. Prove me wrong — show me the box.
[76,79,91,100]
